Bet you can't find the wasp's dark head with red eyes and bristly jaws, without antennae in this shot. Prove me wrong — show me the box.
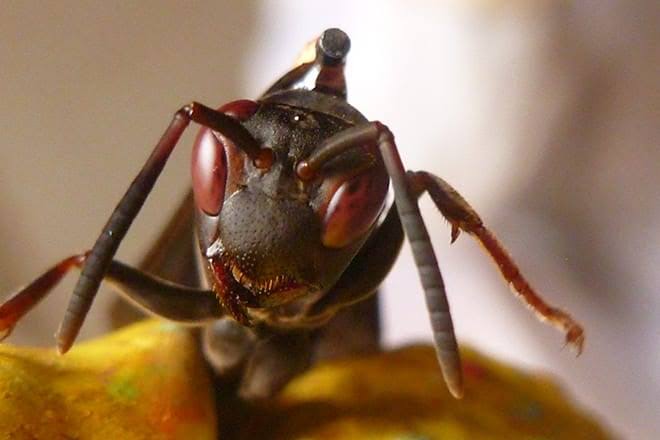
[192,97,388,321]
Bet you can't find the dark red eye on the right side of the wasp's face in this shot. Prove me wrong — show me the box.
[321,167,389,248]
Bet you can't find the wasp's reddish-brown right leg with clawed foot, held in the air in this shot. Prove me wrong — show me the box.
[408,171,584,355]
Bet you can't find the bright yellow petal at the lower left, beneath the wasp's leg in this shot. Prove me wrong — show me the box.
[0,321,216,440]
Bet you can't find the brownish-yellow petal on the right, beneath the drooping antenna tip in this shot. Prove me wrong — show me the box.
[232,346,608,440]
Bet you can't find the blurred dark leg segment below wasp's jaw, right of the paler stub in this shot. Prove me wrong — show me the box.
[238,330,313,400]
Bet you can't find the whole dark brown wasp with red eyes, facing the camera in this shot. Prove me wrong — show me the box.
[0,29,584,399]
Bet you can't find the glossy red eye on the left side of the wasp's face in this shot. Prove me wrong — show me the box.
[191,128,227,216]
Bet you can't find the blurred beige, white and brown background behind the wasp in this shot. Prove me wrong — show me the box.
[0,0,660,439]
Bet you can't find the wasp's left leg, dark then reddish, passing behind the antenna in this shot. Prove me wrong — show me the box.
[0,253,223,339]
